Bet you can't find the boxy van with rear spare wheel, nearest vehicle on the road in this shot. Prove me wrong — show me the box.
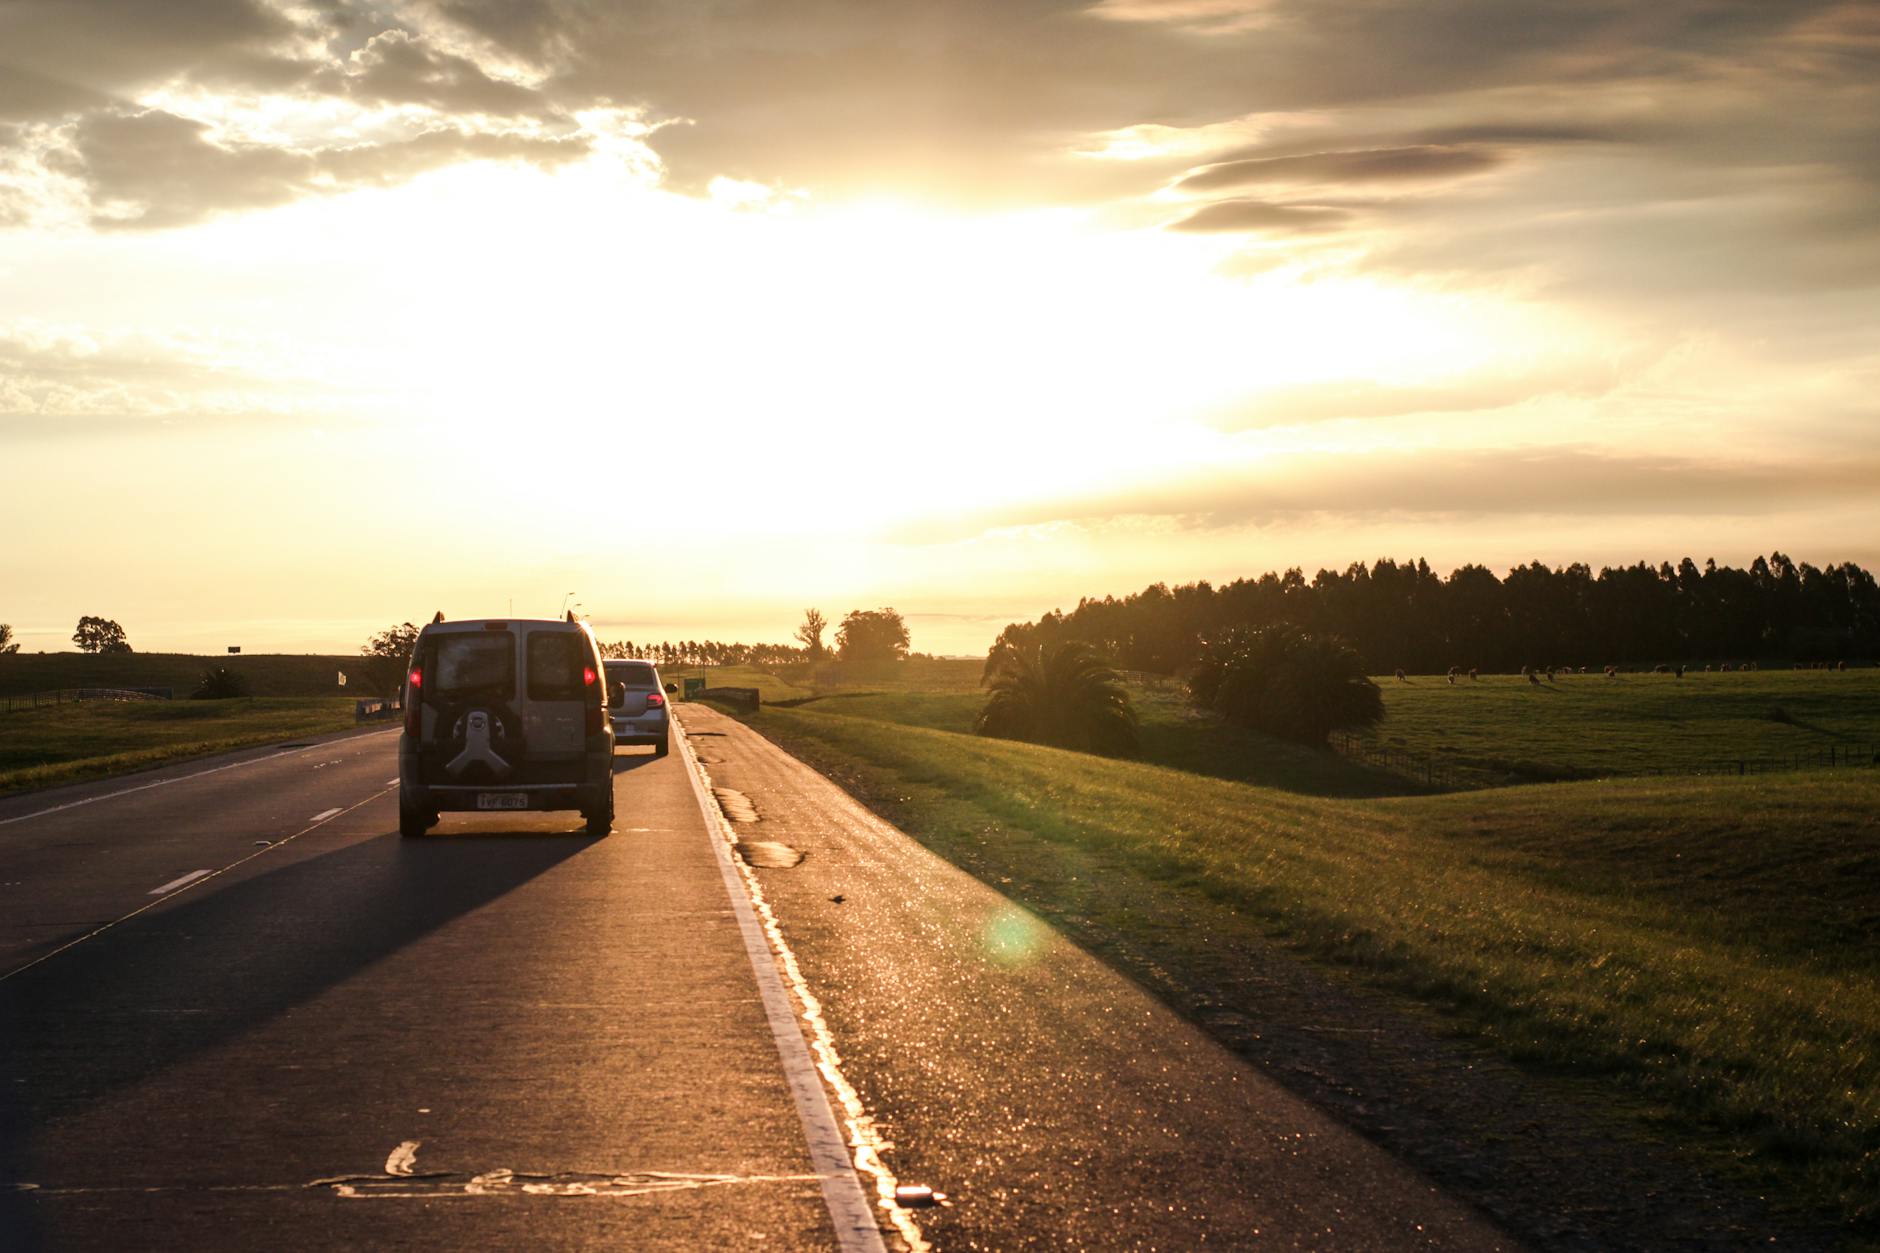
[399,613,613,835]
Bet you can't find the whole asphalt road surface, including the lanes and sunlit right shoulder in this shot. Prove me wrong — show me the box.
[0,706,1512,1249]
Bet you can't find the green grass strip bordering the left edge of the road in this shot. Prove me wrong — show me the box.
[0,696,353,796]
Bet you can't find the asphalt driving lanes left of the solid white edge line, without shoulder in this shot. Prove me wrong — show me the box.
[0,734,861,1249]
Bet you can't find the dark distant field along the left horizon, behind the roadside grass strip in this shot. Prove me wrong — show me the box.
[0,653,378,698]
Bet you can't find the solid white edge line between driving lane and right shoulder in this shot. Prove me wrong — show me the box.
[675,707,887,1253]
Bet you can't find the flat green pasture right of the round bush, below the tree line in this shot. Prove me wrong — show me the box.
[1369,670,1880,786]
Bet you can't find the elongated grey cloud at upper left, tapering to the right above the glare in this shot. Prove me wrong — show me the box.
[49,109,587,230]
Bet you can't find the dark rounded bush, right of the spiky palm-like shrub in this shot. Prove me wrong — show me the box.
[1188,627,1384,745]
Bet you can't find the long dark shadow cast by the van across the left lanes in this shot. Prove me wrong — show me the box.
[0,833,594,1189]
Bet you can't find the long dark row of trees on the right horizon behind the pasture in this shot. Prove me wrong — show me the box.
[993,553,1880,674]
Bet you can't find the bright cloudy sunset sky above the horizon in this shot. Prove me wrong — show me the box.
[0,0,1880,655]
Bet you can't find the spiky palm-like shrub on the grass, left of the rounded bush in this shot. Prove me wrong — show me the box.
[972,640,1137,756]
